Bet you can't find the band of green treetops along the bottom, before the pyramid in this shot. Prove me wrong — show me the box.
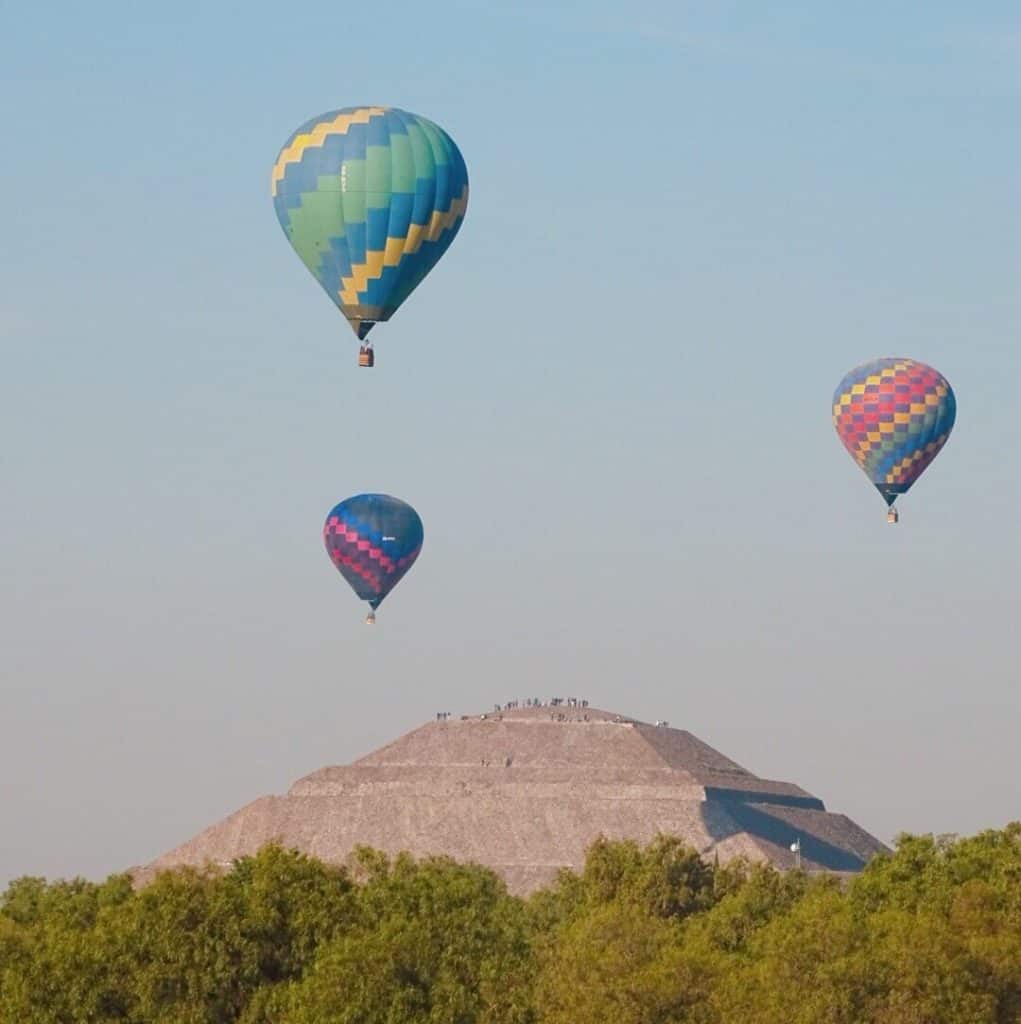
[0,824,1021,1024]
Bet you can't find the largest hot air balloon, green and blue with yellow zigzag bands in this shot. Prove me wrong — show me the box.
[271,106,468,367]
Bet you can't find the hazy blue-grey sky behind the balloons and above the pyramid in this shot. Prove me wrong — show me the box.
[0,0,1021,883]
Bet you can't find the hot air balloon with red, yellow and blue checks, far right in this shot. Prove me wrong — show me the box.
[833,357,958,522]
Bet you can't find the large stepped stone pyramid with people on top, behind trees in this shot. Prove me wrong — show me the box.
[136,698,886,894]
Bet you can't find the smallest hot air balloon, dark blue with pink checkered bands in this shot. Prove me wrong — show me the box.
[323,495,423,625]
